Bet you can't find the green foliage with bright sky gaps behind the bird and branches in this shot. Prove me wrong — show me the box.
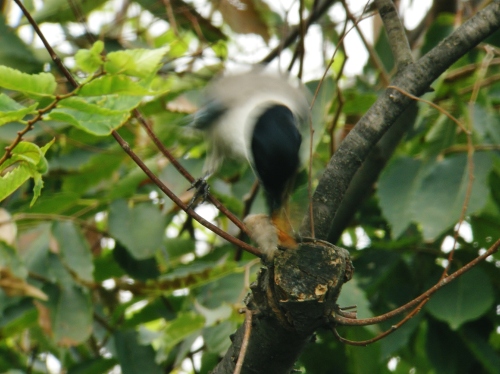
[0,0,500,374]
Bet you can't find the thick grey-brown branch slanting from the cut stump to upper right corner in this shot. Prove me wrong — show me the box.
[301,2,500,239]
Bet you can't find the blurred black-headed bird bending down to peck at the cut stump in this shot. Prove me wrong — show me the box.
[192,68,310,258]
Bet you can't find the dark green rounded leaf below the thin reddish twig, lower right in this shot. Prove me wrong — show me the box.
[426,268,495,330]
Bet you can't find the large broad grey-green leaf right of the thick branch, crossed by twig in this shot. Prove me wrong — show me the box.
[377,152,492,240]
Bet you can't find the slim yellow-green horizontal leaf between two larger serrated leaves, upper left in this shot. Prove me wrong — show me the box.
[78,75,156,96]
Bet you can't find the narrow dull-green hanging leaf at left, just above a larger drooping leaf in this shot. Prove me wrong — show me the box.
[52,221,94,282]
